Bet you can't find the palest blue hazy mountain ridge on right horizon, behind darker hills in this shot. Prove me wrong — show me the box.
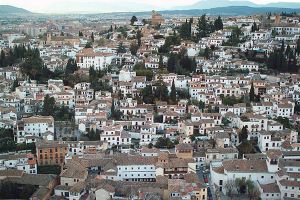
[174,0,300,10]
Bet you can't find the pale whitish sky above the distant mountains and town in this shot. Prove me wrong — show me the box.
[0,0,300,13]
